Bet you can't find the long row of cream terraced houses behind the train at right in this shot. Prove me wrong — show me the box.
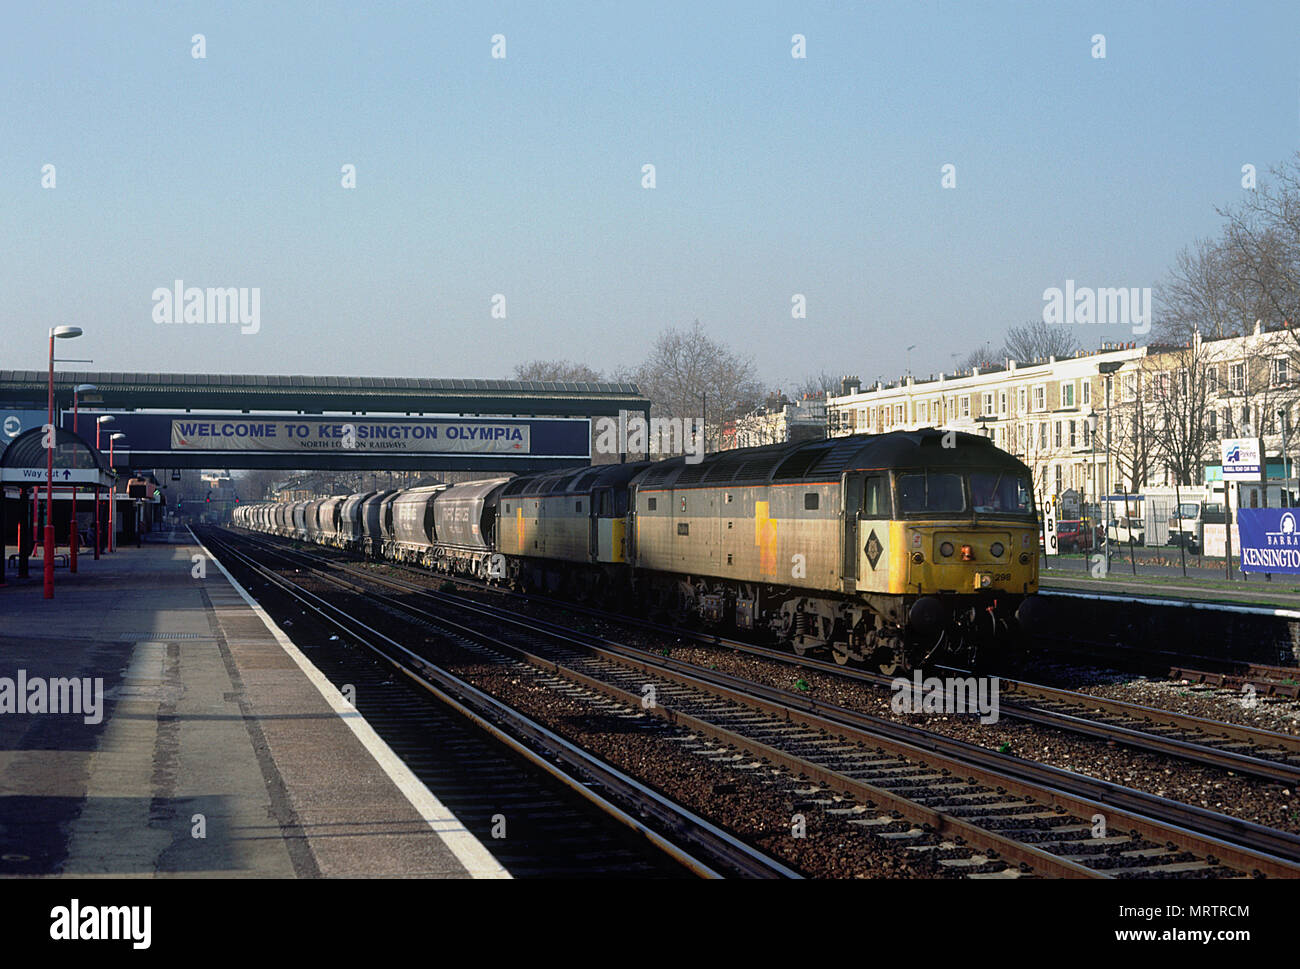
[827,325,1300,499]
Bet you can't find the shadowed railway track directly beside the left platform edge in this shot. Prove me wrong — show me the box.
[197,533,798,878]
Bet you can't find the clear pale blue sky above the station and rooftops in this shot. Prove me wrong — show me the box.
[0,3,1300,385]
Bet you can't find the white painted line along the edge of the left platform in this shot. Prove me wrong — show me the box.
[190,531,511,878]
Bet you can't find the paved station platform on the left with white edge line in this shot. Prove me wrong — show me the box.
[0,532,508,878]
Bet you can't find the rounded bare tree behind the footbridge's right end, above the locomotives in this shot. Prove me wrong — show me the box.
[627,320,763,450]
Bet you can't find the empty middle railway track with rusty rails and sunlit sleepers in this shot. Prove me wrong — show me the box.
[218,525,1300,877]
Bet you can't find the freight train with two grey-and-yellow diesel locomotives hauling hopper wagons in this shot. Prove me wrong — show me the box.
[234,428,1039,674]
